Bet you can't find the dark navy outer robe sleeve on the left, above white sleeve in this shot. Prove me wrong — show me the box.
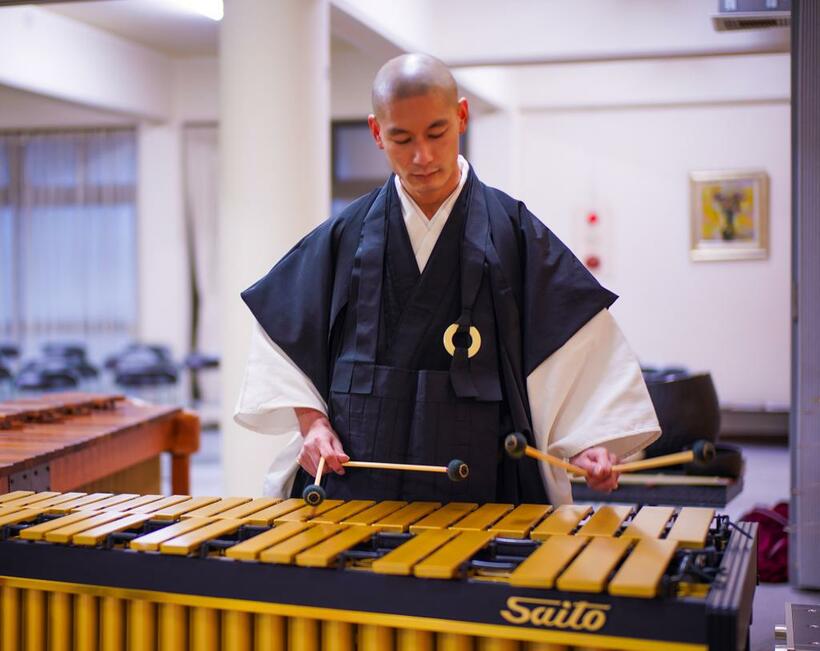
[242,193,375,400]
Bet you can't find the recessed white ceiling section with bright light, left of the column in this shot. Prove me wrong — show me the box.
[42,0,219,57]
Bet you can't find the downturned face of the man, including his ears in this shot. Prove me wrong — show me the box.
[368,91,468,205]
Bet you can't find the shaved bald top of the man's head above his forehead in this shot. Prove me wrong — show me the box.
[371,54,458,118]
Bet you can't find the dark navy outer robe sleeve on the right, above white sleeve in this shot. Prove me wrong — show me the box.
[518,203,618,375]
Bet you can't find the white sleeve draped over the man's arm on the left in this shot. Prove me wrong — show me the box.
[233,322,327,434]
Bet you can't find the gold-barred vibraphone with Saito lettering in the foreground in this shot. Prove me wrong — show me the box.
[0,491,756,651]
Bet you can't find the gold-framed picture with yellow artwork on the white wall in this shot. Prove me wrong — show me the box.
[689,170,769,261]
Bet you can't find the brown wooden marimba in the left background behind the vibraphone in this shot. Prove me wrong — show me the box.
[0,393,199,494]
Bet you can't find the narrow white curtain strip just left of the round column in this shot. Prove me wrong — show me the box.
[184,125,220,403]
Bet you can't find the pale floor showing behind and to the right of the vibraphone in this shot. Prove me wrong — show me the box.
[167,429,820,651]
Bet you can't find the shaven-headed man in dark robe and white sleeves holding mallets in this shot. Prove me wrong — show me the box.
[236,54,659,504]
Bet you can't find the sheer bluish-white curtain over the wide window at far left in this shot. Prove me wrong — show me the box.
[0,129,137,360]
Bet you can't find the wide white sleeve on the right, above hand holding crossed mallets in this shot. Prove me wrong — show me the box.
[527,310,660,504]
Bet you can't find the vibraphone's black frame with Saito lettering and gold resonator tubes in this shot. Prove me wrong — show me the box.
[0,496,756,651]
